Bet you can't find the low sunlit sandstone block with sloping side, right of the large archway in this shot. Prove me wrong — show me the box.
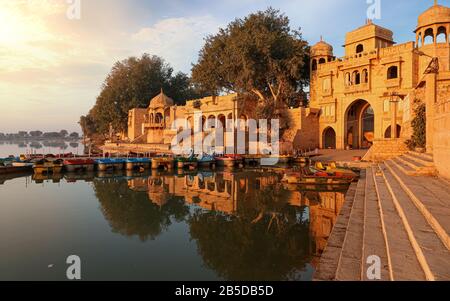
[364,139,408,162]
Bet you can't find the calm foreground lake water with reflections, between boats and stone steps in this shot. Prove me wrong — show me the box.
[0,164,345,280]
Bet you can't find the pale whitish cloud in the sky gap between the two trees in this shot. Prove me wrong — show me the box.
[132,16,221,72]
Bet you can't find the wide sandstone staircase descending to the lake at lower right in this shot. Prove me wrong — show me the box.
[314,157,450,281]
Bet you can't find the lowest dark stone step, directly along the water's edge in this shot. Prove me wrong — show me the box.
[314,179,357,281]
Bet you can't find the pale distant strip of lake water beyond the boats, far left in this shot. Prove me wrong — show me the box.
[0,140,84,158]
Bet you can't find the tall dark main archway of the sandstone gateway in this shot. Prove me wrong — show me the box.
[344,99,375,149]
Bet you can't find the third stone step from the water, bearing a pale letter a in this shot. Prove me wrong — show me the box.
[362,168,391,281]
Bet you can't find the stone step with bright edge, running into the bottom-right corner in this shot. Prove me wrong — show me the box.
[379,162,450,280]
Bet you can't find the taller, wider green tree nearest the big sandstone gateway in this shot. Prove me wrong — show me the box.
[192,8,309,118]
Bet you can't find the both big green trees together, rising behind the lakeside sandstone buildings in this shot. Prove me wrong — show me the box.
[79,7,310,145]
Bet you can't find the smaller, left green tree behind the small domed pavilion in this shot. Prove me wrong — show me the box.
[80,54,204,136]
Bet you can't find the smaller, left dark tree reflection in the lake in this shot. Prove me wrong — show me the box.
[93,179,189,241]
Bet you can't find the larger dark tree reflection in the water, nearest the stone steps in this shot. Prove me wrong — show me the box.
[189,188,310,280]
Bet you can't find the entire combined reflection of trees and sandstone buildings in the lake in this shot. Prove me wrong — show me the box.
[101,170,346,280]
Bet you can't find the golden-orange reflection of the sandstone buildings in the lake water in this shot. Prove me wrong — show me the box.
[128,171,345,262]
